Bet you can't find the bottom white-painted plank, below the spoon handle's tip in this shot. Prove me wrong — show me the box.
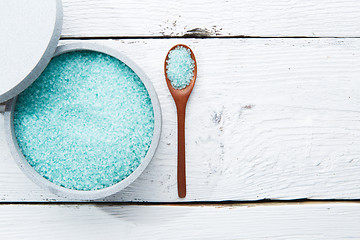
[0,203,360,240]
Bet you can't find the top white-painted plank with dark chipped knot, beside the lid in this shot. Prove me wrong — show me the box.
[62,0,360,38]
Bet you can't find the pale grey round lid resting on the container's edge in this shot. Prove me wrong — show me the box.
[0,0,62,103]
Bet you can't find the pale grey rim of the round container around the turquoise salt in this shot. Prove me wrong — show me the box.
[4,42,162,200]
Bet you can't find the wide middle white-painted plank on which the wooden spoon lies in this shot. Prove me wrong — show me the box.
[0,39,360,202]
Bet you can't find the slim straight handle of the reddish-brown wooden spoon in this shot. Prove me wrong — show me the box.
[176,102,186,198]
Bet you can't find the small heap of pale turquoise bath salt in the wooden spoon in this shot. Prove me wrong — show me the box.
[166,46,195,89]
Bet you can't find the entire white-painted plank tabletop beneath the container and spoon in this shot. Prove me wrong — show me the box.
[0,0,360,240]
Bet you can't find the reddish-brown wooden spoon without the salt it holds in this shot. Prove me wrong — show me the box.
[164,44,197,198]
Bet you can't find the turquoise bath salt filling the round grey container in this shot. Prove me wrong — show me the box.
[14,51,154,191]
